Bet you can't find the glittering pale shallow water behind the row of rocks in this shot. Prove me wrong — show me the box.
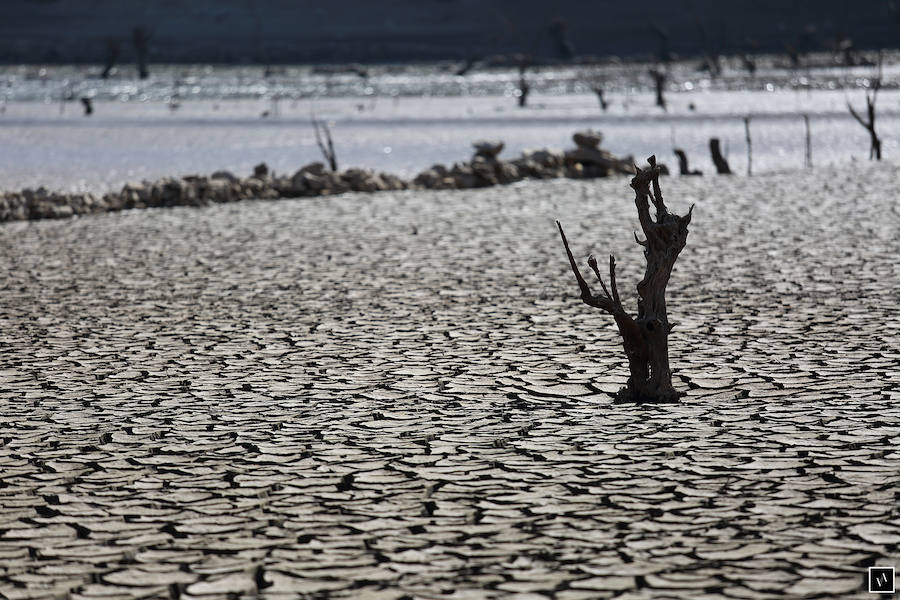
[0,59,900,191]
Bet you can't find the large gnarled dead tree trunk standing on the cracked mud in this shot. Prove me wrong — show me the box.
[556,156,694,402]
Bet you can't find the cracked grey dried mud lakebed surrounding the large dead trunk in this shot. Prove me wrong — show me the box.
[0,167,900,600]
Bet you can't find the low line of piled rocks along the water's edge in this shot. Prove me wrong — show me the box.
[0,130,634,222]
